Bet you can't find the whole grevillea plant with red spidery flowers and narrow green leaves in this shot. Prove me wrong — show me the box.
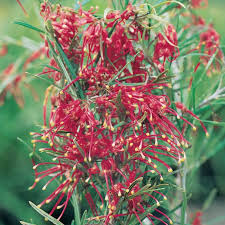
[1,0,224,225]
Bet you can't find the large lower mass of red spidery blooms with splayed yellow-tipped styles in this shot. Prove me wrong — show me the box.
[31,83,207,224]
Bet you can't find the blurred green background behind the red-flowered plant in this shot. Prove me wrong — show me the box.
[0,0,225,225]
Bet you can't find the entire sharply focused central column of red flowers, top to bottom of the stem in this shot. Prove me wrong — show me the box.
[26,2,210,225]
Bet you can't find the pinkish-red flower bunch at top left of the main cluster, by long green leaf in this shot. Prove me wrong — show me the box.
[41,2,96,81]
